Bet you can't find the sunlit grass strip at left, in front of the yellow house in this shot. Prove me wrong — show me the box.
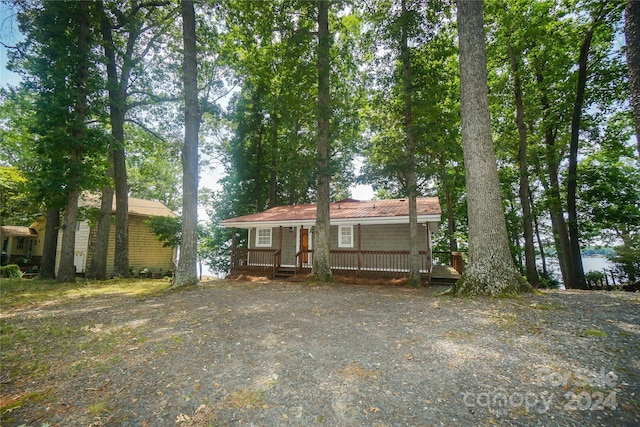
[0,279,170,310]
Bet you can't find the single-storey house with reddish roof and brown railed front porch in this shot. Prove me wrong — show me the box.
[221,197,459,279]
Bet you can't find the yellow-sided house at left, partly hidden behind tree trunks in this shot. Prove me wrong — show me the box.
[31,196,176,276]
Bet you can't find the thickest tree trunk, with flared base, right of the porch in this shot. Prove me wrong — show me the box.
[455,0,531,296]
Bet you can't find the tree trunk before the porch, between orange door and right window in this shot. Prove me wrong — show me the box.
[312,0,332,282]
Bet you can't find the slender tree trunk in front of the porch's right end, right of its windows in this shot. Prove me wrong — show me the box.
[400,0,421,286]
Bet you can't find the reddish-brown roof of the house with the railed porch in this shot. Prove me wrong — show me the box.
[221,197,441,227]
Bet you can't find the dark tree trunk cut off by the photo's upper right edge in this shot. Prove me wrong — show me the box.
[624,0,640,158]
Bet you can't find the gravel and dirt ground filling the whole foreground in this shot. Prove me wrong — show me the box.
[0,280,640,427]
